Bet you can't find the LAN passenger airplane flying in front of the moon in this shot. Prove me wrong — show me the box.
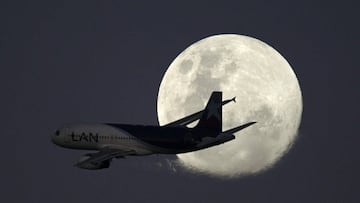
[51,91,256,169]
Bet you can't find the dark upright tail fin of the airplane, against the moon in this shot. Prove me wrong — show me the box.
[195,92,222,136]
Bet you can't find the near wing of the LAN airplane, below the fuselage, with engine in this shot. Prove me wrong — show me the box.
[75,148,134,169]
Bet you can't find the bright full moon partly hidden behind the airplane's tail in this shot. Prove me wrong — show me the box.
[157,34,302,177]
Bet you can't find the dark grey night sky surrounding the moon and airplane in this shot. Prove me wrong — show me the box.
[0,0,360,202]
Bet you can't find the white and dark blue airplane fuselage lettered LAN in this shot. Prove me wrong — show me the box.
[52,124,225,155]
